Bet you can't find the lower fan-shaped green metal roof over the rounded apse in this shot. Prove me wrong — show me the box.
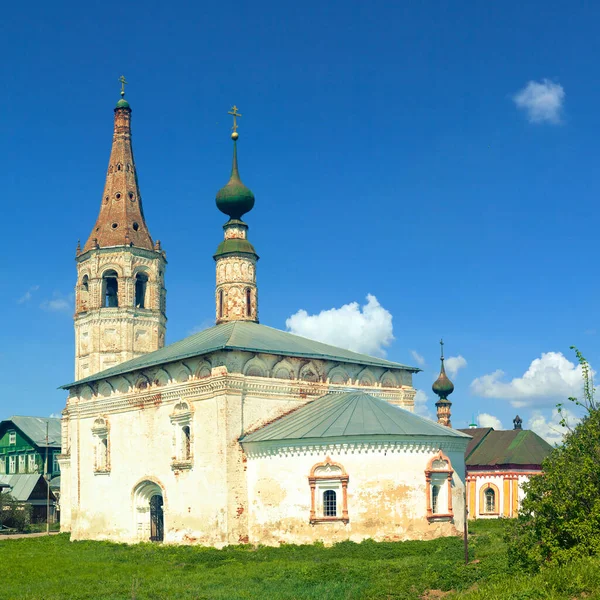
[240,391,469,442]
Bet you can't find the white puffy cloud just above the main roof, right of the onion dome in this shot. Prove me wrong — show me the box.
[285,294,394,356]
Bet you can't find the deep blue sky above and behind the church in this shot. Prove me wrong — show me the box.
[0,0,600,440]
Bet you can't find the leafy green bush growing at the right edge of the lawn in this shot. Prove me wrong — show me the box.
[507,351,600,572]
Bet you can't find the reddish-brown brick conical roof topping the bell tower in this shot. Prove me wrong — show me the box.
[83,83,154,252]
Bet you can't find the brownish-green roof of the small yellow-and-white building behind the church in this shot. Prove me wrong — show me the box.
[462,428,552,467]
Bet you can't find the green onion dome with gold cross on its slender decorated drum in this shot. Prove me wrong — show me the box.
[213,106,258,324]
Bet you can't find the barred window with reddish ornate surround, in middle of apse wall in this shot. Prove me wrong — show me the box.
[308,456,350,525]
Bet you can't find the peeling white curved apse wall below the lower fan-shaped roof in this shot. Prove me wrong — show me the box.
[247,445,464,545]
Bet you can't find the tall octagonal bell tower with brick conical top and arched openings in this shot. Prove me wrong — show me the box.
[74,77,167,379]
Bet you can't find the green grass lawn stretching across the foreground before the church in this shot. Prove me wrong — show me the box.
[0,521,600,600]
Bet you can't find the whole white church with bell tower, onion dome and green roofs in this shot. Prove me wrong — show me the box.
[59,82,471,546]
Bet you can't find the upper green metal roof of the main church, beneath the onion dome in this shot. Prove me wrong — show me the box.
[61,321,420,389]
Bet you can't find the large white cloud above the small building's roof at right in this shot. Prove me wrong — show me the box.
[471,352,583,407]
